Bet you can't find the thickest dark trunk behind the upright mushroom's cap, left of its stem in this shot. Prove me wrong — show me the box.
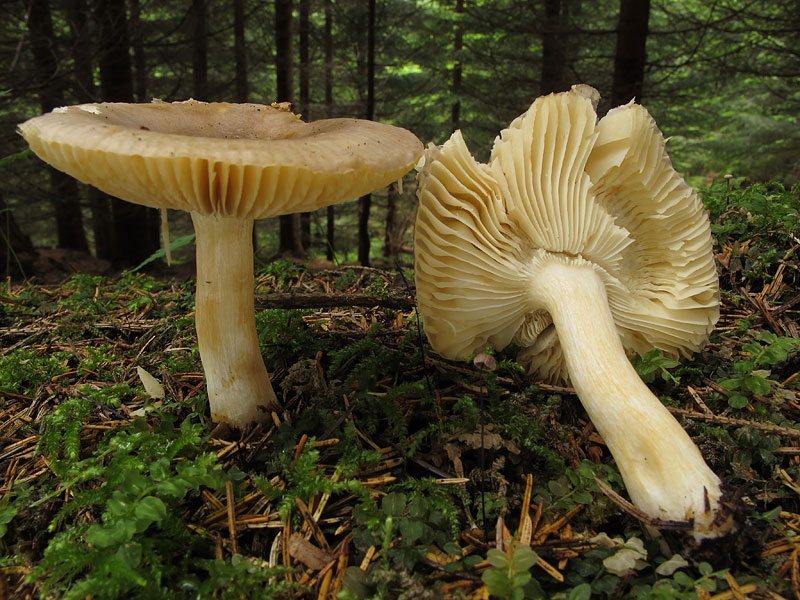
[96,0,159,266]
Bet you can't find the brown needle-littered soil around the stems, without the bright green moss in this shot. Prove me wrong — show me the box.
[0,236,800,600]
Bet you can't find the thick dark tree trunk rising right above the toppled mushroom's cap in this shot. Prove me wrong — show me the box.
[611,0,650,106]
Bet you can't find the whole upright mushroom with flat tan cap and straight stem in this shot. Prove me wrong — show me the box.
[19,100,422,426]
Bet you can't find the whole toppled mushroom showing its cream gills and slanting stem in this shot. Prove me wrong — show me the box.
[415,86,731,539]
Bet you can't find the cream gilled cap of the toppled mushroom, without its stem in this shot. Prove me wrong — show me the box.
[415,90,719,380]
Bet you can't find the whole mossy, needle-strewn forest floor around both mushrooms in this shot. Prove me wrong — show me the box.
[0,180,800,600]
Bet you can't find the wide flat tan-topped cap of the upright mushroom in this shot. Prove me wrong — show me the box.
[19,100,422,219]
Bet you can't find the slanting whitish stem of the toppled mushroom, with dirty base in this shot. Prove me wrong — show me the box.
[530,258,730,540]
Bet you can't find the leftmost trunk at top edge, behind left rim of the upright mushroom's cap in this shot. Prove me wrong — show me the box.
[28,0,89,252]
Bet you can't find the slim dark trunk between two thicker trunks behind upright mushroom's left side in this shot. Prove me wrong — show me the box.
[66,0,115,260]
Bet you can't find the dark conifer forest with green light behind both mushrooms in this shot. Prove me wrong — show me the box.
[0,0,800,275]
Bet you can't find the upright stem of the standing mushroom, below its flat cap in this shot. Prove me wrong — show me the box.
[192,212,278,426]
